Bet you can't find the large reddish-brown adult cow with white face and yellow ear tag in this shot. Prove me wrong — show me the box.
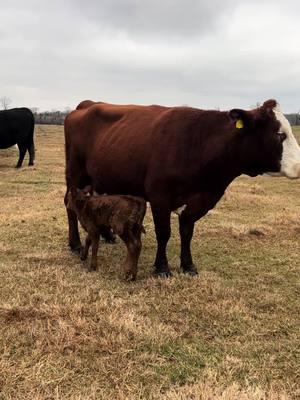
[65,100,300,276]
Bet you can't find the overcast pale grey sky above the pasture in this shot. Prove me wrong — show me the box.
[0,0,300,112]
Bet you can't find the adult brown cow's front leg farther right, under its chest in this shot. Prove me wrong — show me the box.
[179,215,198,275]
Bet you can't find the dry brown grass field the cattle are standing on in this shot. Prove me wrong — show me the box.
[0,126,300,400]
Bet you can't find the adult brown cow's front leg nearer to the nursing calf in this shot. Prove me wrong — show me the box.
[151,204,172,277]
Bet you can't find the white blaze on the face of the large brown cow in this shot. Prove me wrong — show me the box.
[273,105,300,179]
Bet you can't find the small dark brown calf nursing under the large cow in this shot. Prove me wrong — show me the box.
[67,187,146,281]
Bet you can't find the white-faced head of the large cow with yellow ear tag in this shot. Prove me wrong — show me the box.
[229,100,300,179]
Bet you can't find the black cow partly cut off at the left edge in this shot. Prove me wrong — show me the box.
[0,107,34,168]
